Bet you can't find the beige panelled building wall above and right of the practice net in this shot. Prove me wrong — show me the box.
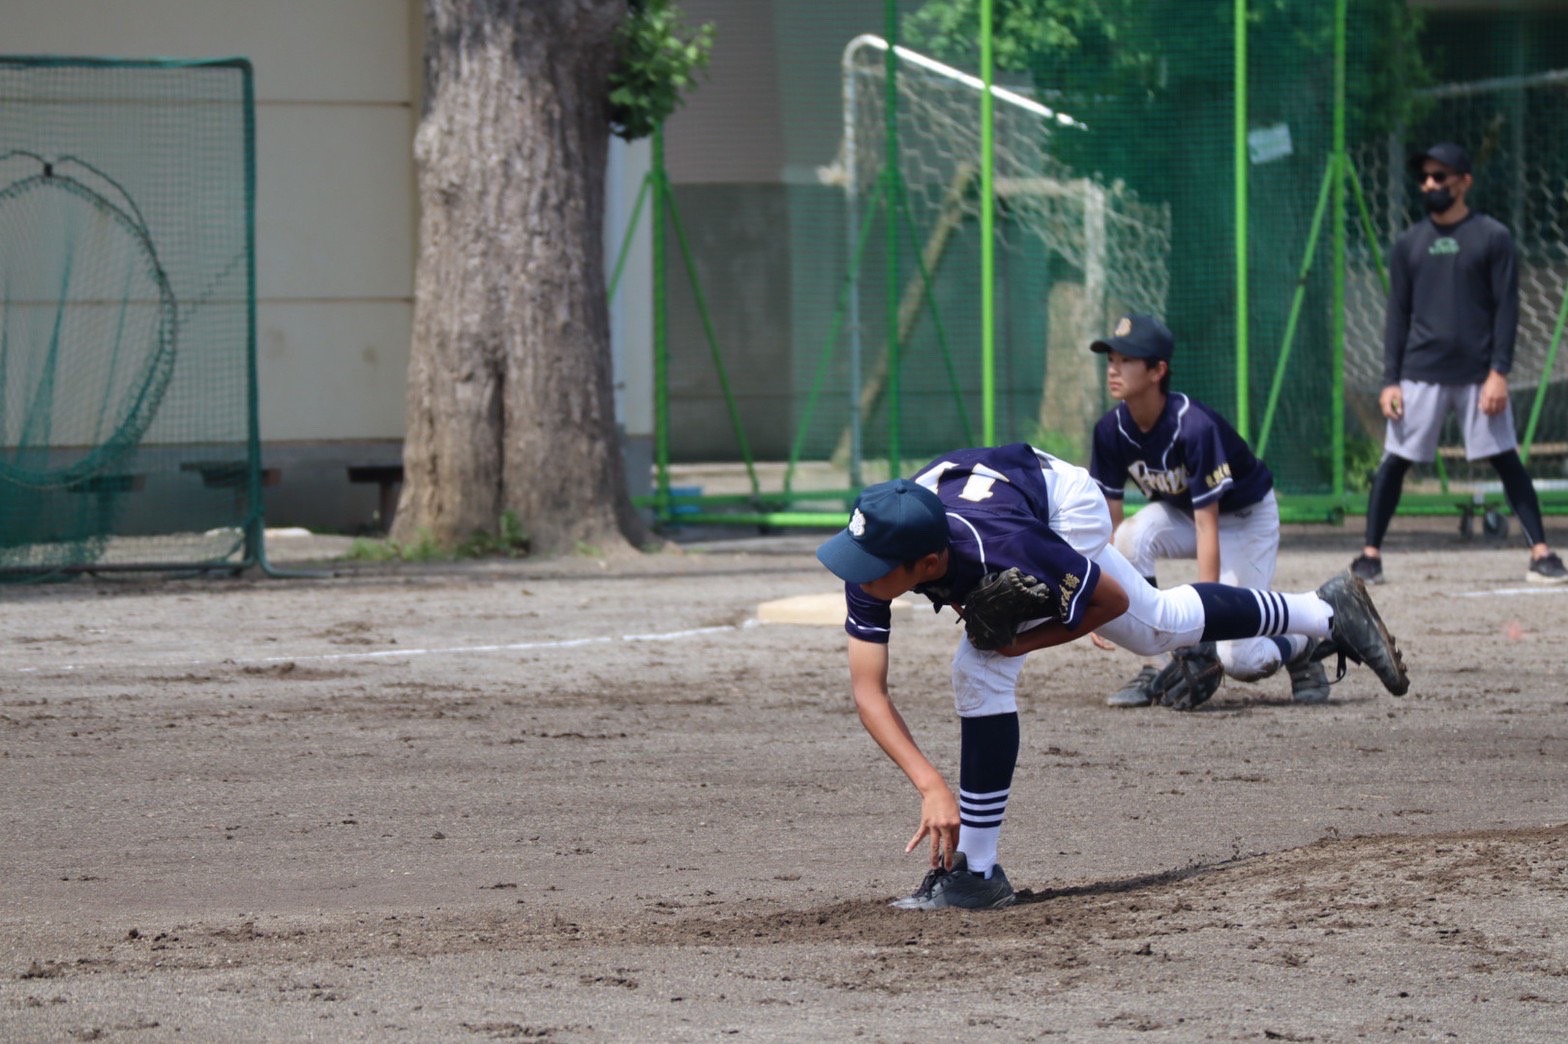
[0,0,422,528]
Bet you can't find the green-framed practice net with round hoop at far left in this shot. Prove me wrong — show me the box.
[0,56,262,578]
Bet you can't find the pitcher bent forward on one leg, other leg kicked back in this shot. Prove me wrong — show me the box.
[817,444,1410,909]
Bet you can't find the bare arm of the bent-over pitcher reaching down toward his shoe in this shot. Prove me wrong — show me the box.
[848,638,958,867]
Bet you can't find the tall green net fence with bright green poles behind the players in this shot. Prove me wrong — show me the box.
[627,0,1568,524]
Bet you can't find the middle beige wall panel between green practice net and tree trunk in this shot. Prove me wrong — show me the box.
[256,105,416,301]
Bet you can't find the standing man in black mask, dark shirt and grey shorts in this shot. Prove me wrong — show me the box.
[1350,141,1568,583]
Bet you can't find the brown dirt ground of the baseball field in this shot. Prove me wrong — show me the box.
[0,517,1568,1041]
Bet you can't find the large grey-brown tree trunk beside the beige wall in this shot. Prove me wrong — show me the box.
[404,0,646,553]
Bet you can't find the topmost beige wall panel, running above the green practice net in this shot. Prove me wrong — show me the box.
[0,0,417,102]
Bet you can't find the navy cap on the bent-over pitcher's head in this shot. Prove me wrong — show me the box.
[817,478,949,583]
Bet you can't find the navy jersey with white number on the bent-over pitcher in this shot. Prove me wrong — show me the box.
[844,442,1099,644]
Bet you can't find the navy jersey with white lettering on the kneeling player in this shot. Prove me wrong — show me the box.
[1088,392,1273,514]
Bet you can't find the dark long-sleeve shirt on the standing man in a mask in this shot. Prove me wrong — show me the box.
[1383,210,1519,386]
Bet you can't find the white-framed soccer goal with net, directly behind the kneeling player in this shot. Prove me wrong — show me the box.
[818,34,1171,472]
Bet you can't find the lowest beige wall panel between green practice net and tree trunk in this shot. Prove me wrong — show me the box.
[256,301,412,442]
